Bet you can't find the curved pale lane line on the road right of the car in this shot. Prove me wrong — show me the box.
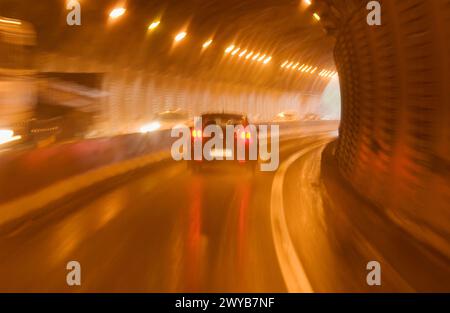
[270,141,328,292]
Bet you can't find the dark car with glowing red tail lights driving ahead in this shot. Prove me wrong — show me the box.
[189,113,258,171]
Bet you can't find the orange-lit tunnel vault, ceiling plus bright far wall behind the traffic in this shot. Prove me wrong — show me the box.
[2,0,339,134]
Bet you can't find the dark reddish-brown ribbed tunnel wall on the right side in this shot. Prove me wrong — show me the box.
[335,0,450,257]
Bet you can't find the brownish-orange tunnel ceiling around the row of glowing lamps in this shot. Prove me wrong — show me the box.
[0,0,334,93]
